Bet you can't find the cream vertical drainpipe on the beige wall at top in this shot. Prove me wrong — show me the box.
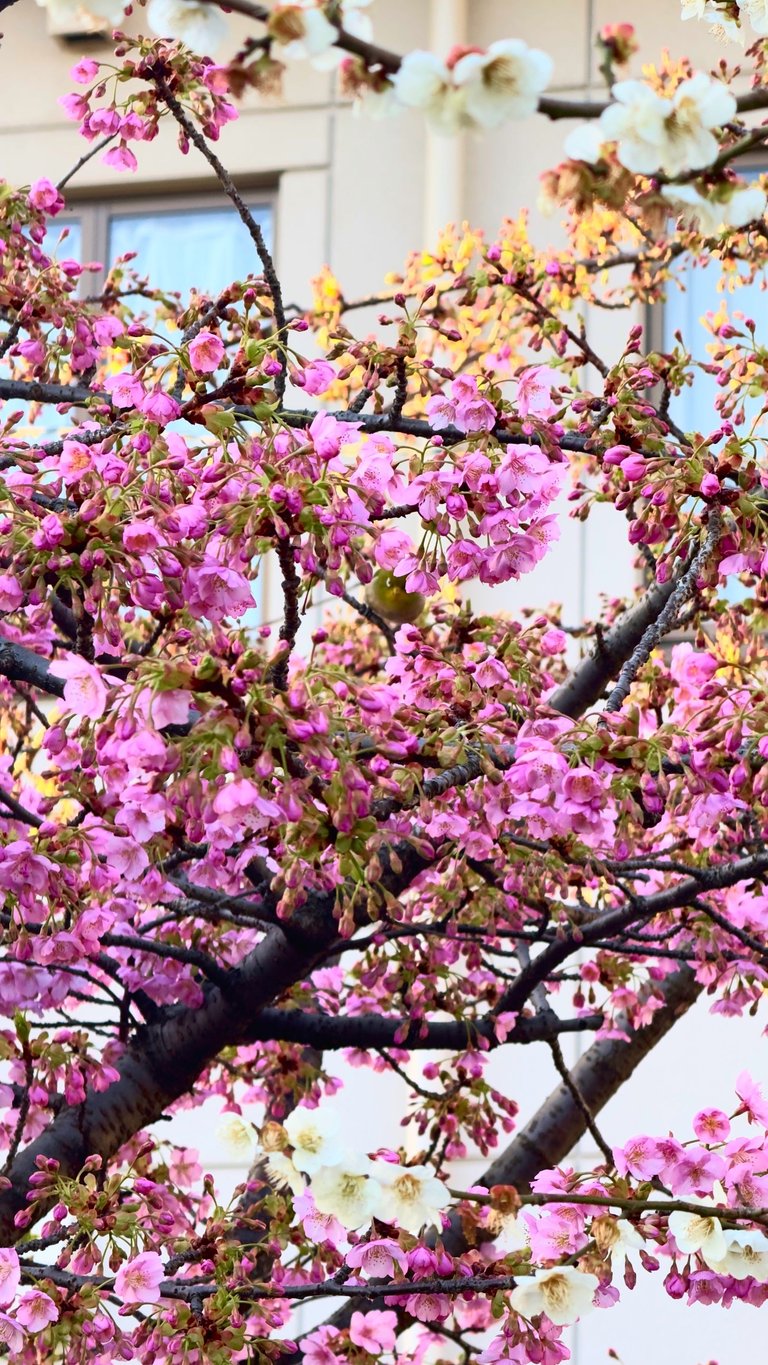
[423,0,468,248]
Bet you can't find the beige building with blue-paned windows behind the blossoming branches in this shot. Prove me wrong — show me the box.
[0,0,768,1365]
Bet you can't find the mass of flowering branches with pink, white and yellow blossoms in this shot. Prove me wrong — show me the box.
[0,0,768,1365]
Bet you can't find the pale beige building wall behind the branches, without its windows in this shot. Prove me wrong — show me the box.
[0,0,767,1365]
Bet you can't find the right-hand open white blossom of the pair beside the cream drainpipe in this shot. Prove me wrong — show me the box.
[453,38,552,128]
